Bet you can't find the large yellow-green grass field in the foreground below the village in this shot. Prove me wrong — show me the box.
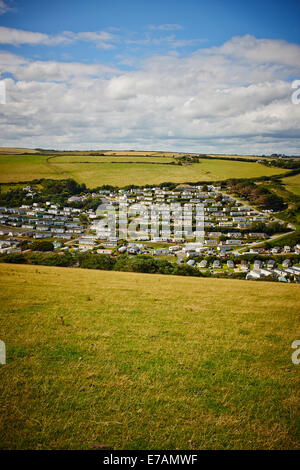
[0,265,300,449]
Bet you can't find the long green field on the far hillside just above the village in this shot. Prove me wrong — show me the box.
[0,155,284,187]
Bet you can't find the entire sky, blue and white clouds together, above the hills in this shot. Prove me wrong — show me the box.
[0,0,300,155]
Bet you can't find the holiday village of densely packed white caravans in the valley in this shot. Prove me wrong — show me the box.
[0,184,300,282]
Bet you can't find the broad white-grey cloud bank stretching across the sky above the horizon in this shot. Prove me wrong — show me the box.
[0,36,300,154]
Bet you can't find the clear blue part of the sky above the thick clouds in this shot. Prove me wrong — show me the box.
[0,0,300,64]
